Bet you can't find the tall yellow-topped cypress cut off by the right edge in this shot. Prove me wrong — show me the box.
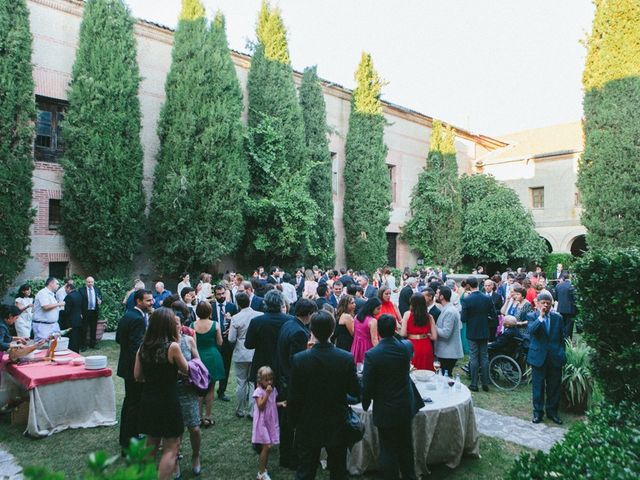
[578,0,640,247]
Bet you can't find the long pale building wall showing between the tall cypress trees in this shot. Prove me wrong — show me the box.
[18,0,573,281]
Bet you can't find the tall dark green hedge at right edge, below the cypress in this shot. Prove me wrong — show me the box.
[575,247,640,403]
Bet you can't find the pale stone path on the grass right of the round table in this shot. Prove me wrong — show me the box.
[475,407,567,452]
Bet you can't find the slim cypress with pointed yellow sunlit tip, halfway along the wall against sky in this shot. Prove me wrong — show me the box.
[343,53,391,272]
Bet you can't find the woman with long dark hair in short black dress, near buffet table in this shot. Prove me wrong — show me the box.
[134,307,189,480]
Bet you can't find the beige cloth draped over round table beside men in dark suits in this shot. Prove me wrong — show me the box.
[347,382,480,476]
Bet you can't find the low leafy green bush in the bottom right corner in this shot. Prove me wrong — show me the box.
[506,404,640,480]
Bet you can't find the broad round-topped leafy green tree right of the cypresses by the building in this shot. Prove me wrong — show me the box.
[460,175,547,265]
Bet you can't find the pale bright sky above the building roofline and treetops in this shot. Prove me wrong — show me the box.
[125,0,594,139]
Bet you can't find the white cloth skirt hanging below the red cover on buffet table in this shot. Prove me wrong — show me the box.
[0,371,117,437]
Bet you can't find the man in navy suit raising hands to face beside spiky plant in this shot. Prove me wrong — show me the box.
[527,292,567,425]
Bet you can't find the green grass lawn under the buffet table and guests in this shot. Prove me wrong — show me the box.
[0,341,536,480]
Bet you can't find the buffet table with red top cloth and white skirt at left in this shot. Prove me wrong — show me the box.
[0,351,117,437]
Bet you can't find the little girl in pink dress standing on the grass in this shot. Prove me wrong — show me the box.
[251,367,287,480]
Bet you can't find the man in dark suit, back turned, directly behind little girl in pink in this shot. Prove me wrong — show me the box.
[244,289,295,386]
